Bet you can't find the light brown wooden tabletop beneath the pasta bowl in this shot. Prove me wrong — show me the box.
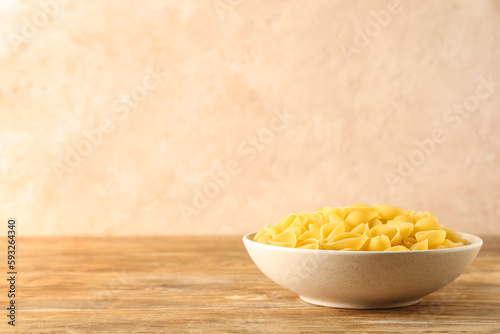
[10,237,500,334]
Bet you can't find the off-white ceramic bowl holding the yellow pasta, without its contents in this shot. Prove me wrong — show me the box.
[243,232,483,309]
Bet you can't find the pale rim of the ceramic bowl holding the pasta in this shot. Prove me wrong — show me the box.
[243,231,483,256]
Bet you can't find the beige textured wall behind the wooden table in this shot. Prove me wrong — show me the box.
[0,0,500,235]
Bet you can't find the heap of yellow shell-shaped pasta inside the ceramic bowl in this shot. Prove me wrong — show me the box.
[254,204,468,251]
